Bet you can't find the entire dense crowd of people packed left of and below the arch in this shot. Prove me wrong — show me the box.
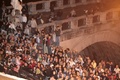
[0,0,120,80]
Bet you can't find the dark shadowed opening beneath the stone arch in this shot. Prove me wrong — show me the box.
[80,41,120,65]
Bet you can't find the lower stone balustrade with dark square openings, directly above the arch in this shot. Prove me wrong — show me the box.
[38,8,120,41]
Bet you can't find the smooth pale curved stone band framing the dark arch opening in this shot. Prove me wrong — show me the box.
[61,30,120,52]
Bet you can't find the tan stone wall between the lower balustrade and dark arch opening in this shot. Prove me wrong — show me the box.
[61,21,120,52]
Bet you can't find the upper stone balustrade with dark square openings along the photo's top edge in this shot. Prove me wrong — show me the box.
[8,0,97,14]
